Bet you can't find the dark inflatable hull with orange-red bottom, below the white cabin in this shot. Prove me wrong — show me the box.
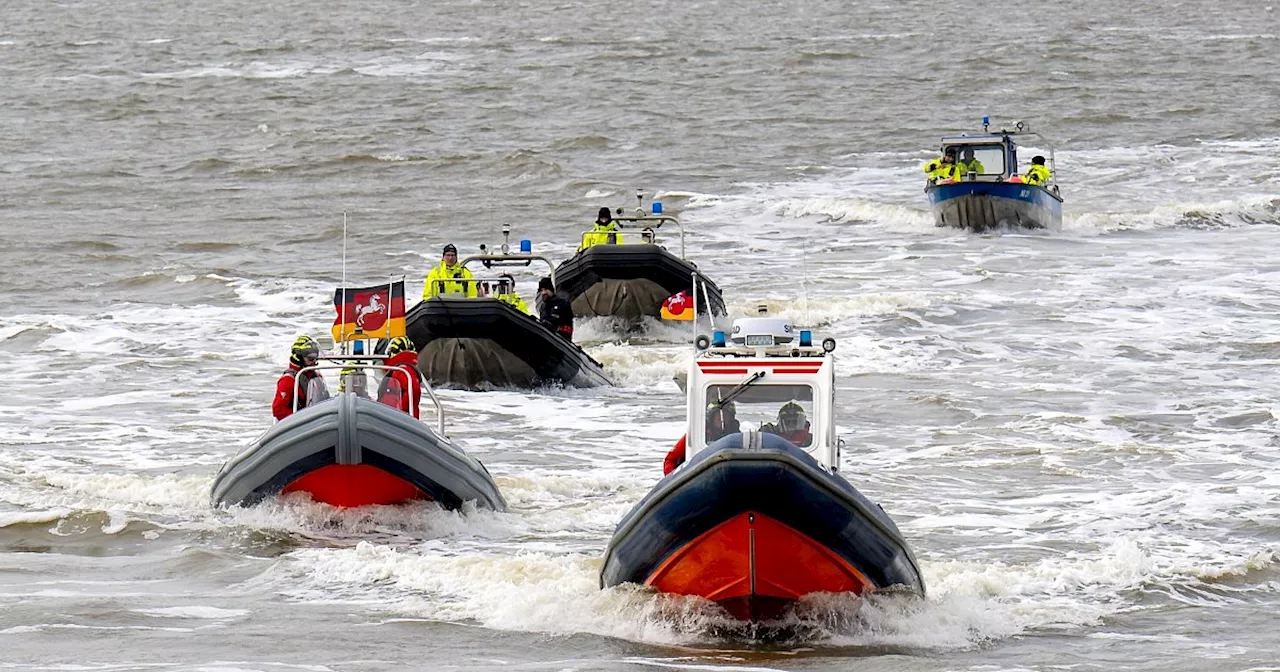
[600,433,924,621]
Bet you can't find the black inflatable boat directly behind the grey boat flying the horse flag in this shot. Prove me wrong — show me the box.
[406,227,612,389]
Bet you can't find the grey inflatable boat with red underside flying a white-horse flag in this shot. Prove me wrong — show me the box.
[210,280,507,511]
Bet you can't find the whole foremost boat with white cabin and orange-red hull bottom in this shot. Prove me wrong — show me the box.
[600,315,925,622]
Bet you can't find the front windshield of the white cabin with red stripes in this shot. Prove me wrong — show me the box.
[705,384,813,448]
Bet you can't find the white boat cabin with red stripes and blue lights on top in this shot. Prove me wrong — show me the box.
[686,316,840,472]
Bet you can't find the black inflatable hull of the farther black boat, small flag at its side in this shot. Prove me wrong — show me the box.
[556,244,727,320]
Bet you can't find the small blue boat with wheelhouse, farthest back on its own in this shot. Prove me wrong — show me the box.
[924,116,1062,232]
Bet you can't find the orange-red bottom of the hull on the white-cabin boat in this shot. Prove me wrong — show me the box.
[645,511,876,621]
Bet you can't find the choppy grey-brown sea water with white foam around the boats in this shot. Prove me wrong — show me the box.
[0,0,1280,671]
